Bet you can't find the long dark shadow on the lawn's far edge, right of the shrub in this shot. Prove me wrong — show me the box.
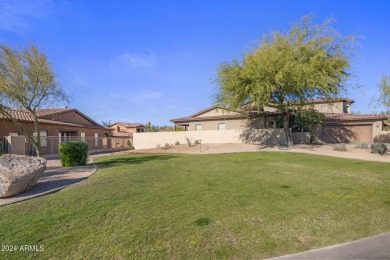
[96,155,177,169]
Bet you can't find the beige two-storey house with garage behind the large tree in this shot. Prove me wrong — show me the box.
[171,98,388,143]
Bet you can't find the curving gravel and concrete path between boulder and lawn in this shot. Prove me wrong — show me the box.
[0,159,97,207]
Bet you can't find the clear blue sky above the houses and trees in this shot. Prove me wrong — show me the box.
[0,0,390,125]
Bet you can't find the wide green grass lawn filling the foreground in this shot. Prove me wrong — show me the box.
[0,152,390,259]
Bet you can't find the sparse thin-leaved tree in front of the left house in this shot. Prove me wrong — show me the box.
[0,44,69,156]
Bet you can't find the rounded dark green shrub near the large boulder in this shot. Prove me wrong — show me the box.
[58,141,88,167]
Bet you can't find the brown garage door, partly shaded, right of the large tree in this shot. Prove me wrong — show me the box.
[322,124,372,143]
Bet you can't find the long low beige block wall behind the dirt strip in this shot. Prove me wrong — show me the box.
[133,129,310,149]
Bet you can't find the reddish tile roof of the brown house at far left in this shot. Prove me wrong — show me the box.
[0,110,105,129]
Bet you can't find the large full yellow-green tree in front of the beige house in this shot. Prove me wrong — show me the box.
[215,16,353,147]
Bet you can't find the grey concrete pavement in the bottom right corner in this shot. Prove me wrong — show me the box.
[272,232,390,260]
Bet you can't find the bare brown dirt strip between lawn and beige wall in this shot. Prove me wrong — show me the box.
[100,143,390,162]
